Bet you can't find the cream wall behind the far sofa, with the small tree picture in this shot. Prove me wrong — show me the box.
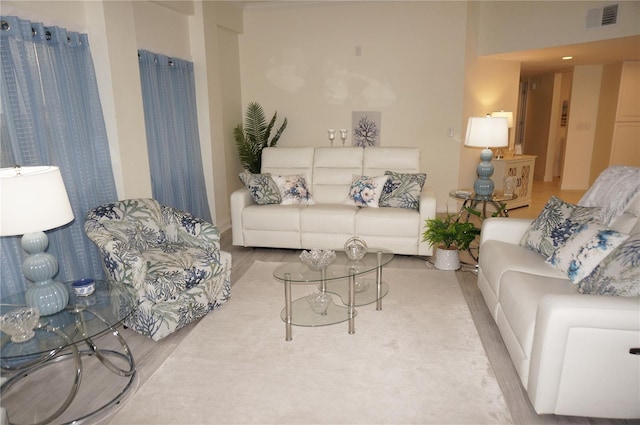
[240,2,466,209]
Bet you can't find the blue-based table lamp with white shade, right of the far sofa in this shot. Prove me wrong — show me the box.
[464,116,509,198]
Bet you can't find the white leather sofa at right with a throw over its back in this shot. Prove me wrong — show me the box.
[478,166,640,418]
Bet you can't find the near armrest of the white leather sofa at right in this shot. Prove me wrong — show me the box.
[527,294,640,418]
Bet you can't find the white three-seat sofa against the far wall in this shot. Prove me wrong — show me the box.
[231,147,436,255]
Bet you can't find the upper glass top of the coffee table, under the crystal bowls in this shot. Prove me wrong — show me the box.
[273,248,393,283]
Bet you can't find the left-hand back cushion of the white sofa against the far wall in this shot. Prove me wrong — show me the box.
[261,147,314,187]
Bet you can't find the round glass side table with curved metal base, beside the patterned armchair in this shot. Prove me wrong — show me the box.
[0,280,138,424]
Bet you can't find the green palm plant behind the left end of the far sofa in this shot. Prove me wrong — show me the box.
[233,102,287,174]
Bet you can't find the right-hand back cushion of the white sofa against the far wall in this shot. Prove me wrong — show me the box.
[362,147,420,177]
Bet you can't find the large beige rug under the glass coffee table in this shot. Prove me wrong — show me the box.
[110,262,511,425]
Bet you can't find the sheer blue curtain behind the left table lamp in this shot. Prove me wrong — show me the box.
[0,16,117,297]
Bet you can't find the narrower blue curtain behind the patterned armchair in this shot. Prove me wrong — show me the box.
[138,50,211,222]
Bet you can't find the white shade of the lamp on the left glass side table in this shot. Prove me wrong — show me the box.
[0,166,73,236]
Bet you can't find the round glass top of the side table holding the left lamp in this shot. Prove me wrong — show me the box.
[0,280,139,366]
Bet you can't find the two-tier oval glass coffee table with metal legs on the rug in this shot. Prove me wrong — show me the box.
[273,248,393,341]
